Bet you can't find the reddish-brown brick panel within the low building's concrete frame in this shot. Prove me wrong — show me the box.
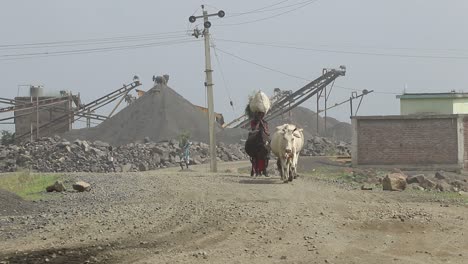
[353,116,458,165]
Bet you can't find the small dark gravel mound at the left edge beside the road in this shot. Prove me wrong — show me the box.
[0,189,34,216]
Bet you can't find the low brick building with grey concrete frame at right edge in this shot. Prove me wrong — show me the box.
[352,115,468,170]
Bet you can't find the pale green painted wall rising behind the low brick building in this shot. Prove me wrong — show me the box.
[400,98,454,115]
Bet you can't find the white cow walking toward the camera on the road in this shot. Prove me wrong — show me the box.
[271,124,304,182]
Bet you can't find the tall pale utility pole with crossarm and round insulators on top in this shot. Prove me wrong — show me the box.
[189,5,225,172]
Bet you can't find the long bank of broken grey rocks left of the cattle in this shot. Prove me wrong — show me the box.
[0,137,247,172]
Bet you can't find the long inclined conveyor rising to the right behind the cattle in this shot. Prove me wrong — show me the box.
[223,66,346,128]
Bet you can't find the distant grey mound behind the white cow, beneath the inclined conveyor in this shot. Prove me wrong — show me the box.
[269,106,352,142]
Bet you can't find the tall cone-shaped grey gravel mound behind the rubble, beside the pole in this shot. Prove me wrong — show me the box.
[63,84,220,145]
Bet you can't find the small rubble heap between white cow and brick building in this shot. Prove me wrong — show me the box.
[301,136,351,156]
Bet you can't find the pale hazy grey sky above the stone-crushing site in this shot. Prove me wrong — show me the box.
[0,0,468,129]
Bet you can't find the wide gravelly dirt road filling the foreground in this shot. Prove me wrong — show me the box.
[0,160,468,264]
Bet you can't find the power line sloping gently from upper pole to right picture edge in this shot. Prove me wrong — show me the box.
[216,39,468,60]
